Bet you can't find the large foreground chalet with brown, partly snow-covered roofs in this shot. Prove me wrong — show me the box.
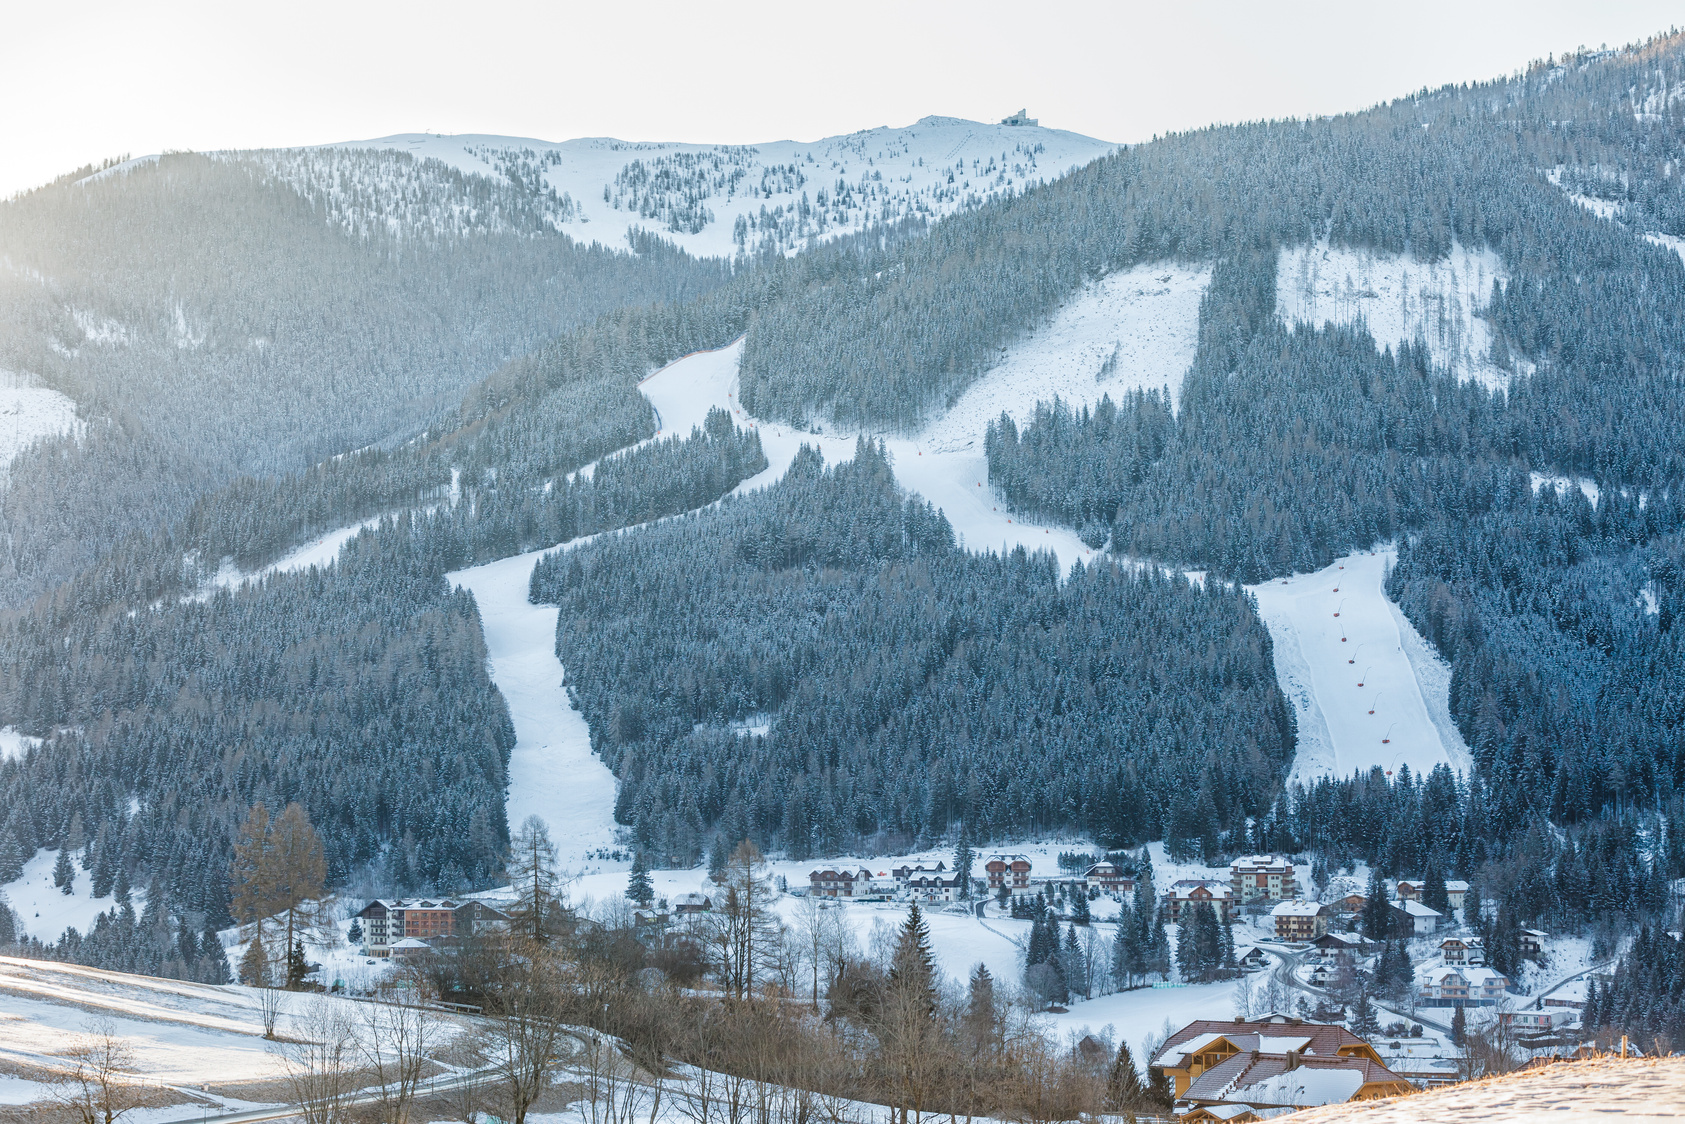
[1147,1014,1409,1121]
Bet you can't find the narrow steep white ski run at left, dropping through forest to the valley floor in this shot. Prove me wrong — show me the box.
[448,551,615,870]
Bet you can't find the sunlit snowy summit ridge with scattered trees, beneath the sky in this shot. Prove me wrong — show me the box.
[316,116,1114,256]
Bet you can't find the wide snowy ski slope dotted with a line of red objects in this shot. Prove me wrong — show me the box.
[1247,549,1471,780]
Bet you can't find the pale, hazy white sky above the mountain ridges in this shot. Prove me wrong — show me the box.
[0,0,1685,197]
